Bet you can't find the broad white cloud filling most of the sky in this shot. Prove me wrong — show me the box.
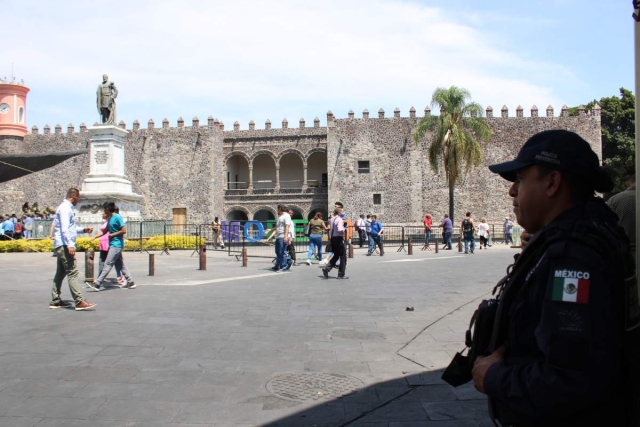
[5,0,577,128]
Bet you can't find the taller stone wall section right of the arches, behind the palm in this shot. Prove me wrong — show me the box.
[327,107,602,224]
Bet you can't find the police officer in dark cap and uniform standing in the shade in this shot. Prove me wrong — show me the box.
[472,130,640,427]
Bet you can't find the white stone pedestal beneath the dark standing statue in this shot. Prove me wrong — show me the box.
[77,125,143,221]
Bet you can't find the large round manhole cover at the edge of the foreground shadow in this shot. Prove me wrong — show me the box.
[266,372,364,401]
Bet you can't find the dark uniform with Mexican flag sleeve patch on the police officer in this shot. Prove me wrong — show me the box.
[484,199,640,426]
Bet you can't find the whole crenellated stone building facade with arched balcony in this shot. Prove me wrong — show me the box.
[0,106,601,224]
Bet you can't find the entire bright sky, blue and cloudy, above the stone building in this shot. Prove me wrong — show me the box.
[0,0,635,129]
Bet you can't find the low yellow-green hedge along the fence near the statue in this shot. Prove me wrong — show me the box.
[0,235,204,253]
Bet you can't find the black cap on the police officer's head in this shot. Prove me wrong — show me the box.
[489,130,613,192]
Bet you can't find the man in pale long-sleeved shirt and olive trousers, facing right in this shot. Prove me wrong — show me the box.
[49,188,96,311]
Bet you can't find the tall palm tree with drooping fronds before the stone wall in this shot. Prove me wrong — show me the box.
[413,86,491,222]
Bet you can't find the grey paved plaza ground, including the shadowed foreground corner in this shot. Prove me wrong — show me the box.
[0,244,516,427]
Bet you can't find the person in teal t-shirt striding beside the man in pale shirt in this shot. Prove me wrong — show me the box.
[87,202,137,291]
